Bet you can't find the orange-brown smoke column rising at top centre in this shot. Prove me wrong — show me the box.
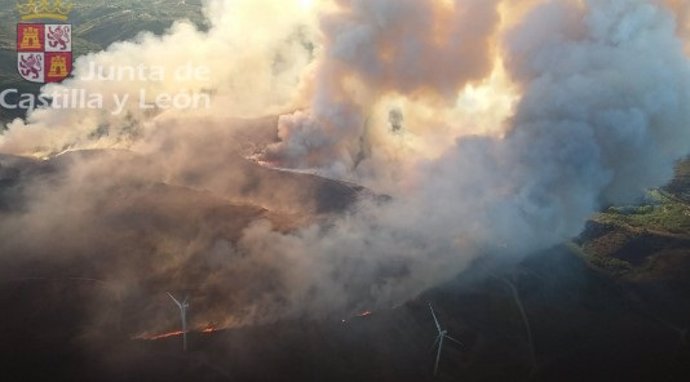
[267,0,498,176]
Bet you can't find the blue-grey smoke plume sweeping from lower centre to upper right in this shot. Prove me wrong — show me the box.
[245,0,690,314]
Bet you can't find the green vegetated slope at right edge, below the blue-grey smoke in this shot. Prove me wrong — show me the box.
[576,161,690,280]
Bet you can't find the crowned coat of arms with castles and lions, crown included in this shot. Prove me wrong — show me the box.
[17,0,74,84]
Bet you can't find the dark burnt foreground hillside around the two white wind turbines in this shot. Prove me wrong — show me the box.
[0,151,690,382]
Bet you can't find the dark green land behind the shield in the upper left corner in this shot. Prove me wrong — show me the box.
[0,0,207,122]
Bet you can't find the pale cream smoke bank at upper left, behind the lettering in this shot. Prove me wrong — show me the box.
[0,0,315,156]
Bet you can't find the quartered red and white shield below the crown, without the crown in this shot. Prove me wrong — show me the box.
[17,23,72,84]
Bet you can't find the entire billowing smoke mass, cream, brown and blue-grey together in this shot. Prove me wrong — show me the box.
[0,0,690,334]
